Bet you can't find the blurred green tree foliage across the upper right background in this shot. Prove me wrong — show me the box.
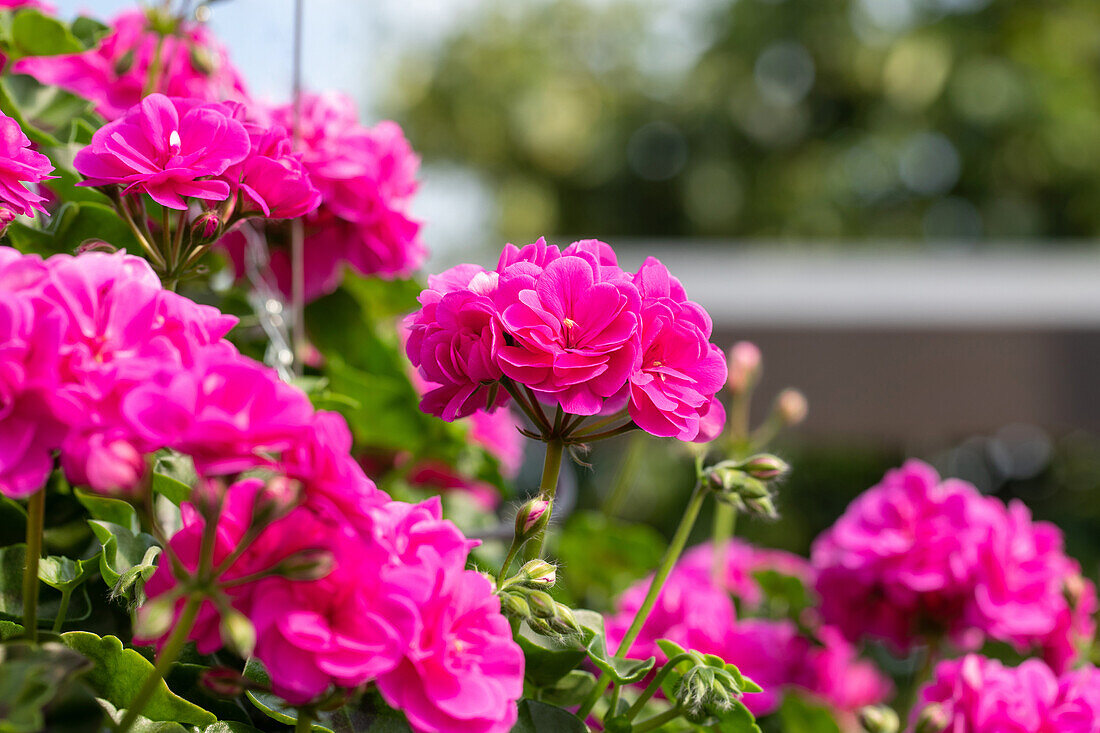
[389,0,1100,241]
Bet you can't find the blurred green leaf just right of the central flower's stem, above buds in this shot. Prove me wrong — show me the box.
[553,512,666,608]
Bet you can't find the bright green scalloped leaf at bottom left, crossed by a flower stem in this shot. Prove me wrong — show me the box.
[62,632,217,725]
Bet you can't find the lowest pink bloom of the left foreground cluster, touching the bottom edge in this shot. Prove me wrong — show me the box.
[378,566,524,733]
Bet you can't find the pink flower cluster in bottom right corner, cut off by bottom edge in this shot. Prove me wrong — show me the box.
[920,654,1100,733]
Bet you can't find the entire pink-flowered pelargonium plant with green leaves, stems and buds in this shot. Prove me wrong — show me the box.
[0,0,1100,733]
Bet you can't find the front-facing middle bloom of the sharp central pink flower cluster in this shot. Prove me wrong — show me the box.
[494,244,641,415]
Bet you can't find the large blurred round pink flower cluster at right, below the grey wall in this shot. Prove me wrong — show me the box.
[812,460,1097,670]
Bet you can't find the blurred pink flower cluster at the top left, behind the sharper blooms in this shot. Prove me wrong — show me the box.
[12,9,246,120]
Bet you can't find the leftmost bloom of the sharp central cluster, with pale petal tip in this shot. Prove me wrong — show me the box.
[405,265,508,422]
